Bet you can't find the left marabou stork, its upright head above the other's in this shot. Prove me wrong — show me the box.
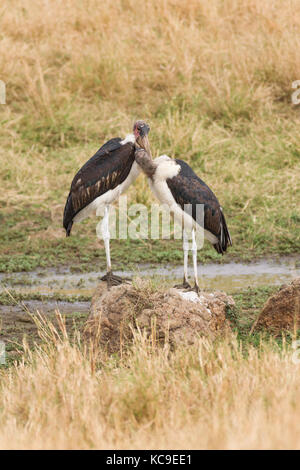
[63,121,151,286]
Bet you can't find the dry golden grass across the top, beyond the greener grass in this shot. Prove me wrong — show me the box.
[0,0,300,108]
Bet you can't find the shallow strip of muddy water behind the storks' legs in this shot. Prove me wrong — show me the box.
[0,256,300,295]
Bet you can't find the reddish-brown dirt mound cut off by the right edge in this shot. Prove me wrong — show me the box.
[252,277,300,334]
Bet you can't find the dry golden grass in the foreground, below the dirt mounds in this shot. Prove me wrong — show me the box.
[0,314,300,449]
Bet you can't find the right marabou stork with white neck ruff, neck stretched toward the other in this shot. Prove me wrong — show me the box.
[135,149,232,293]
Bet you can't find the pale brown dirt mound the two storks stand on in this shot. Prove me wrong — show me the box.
[85,280,234,353]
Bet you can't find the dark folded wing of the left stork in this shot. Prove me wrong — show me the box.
[63,138,135,236]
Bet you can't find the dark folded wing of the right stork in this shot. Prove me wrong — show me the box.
[167,159,232,253]
